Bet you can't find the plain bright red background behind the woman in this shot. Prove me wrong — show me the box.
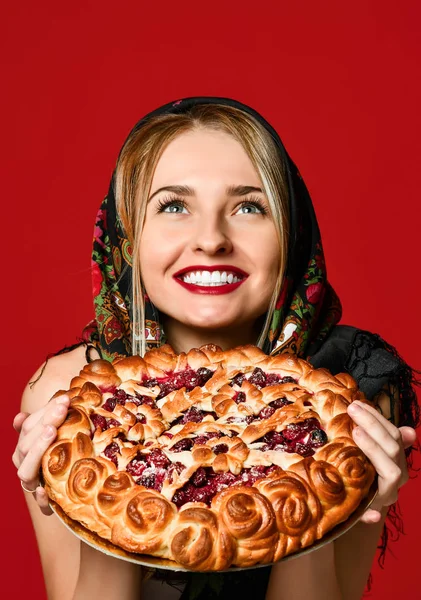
[1,0,421,600]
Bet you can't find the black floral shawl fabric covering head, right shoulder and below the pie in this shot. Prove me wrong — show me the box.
[37,97,419,600]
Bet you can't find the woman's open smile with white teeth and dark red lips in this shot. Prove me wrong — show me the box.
[173,265,248,294]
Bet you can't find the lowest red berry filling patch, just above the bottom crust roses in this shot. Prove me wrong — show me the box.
[172,465,278,507]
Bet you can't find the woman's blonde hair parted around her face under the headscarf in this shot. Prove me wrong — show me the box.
[115,104,289,356]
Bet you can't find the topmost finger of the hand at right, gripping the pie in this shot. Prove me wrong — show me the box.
[348,402,404,466]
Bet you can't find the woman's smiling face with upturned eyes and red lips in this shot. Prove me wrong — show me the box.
[140,129,280,338]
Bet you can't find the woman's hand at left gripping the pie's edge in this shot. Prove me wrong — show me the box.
[12,394,70,515]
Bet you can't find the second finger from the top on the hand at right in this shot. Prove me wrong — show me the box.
[352,427,400,506]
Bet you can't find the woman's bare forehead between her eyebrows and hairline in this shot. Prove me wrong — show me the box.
[152,129,260,188]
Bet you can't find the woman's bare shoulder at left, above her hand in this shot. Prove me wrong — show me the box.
[21,346,99,413]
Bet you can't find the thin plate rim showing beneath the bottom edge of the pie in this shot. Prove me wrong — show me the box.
[49,477,378,571]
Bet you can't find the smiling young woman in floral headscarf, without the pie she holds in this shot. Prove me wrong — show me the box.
[13,98,419,600]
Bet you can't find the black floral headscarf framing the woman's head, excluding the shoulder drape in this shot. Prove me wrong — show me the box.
[83,97,341,360]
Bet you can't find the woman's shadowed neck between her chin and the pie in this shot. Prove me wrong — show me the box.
[163,319,262,354]
